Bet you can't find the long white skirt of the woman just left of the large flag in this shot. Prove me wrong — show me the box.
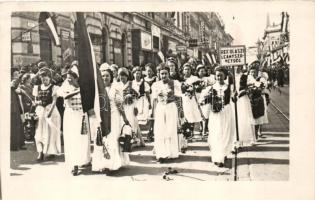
[63,108,91,169]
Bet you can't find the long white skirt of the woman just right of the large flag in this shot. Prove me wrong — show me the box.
[92,110,130,171]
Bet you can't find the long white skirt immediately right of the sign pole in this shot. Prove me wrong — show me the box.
[233,95,256,145]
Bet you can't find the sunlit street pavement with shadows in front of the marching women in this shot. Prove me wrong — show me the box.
[10,86,289,181]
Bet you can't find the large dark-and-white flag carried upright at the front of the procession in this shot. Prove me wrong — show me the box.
[77,12,110,136]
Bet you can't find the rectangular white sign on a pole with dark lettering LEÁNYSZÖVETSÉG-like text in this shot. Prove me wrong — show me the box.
[219,45,246,66]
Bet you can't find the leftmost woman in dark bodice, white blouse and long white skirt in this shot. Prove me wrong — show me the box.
[33,68,61,162]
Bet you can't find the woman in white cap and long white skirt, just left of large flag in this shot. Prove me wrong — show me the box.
[57,65,91,176]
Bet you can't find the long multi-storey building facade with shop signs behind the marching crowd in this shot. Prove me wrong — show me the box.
[11,12,233,67]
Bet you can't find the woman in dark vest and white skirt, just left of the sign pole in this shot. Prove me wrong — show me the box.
[206,66,235,167]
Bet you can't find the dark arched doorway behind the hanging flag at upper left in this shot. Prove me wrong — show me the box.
[38,12,52,62]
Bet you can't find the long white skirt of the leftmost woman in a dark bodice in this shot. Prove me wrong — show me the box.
[35,104,61,155]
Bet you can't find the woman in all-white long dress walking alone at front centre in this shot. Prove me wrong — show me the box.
[152,63,181,163]
